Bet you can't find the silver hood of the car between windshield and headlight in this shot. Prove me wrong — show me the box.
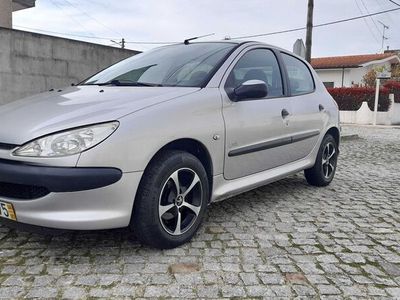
[0,86,199,145]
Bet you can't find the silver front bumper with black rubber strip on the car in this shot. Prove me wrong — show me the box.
[0,160,142,230]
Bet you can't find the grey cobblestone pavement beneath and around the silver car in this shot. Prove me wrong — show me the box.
[0,127,400,299]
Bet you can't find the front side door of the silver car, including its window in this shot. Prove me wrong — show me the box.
[221,48,292,179]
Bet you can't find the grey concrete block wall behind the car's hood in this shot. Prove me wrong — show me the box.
[0,28,138,105]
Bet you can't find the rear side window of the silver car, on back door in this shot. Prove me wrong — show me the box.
[282,53,314,96]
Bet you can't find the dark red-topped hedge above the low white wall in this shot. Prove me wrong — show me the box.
[328,87,390,111]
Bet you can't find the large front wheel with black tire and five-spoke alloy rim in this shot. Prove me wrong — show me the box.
[131,150,210,249]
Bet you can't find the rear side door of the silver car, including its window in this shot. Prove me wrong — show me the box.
[281,53,327,161]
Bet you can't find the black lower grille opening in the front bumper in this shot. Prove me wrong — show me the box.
[0,182,50,200]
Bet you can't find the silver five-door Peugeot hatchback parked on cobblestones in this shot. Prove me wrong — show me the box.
[0,41,340,248]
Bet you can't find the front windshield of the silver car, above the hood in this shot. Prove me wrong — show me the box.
[83,43,235,87]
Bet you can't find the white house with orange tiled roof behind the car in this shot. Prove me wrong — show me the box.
[311,53,400,87]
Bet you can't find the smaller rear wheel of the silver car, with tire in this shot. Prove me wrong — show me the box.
[304,134,339,186]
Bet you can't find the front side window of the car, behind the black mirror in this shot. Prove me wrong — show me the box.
[225,49,283,97]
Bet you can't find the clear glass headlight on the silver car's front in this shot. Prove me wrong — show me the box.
[13,121,119,157]
